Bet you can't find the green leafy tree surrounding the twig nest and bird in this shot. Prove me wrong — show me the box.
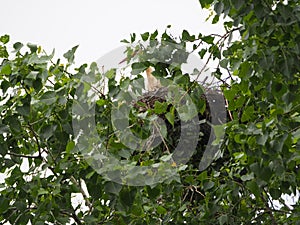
[0,0,300,225]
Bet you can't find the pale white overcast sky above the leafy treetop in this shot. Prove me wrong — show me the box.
[0,0,222,64]
